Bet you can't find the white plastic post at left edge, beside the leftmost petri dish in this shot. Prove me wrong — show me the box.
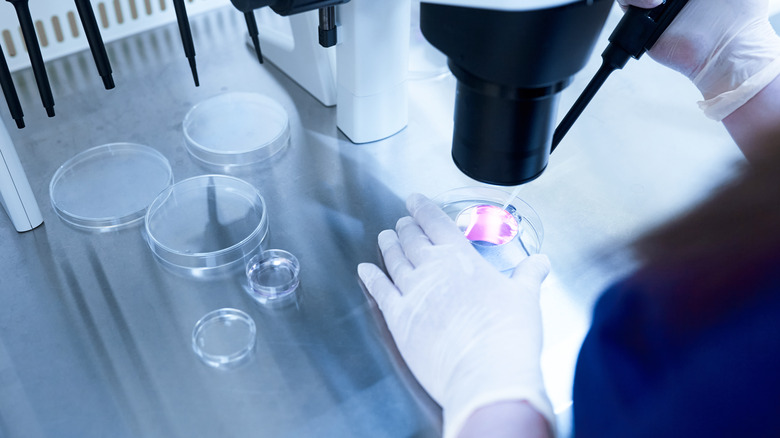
[0,122,43,233]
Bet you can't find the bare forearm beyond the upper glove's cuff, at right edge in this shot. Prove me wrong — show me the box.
[723,76,780,161]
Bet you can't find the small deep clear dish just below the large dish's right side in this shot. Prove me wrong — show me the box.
[246,249,301,300]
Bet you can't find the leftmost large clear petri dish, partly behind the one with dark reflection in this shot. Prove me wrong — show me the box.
[49,143,173,230]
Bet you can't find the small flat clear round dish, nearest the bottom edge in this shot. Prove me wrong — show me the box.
[192,308,257,369]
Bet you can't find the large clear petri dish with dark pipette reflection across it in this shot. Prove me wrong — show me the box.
[145,175,268,277]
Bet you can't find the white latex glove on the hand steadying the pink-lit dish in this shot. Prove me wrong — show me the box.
[358,195,555,437]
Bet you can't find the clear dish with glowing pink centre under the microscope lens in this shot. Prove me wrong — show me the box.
[433,187,544,272]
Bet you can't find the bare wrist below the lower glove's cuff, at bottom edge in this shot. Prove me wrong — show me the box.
[458,401,553,438]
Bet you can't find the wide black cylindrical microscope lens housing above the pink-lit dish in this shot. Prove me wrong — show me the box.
[420,0,613,186]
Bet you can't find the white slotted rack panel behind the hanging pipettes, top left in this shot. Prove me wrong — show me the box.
[0,0,229,71]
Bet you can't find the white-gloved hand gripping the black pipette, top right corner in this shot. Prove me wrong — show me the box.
[618,0,780,121]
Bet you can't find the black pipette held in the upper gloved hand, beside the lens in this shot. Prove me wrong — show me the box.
[551,0,688,152]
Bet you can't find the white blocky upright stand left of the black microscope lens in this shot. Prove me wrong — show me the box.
[261,0,411,144]
